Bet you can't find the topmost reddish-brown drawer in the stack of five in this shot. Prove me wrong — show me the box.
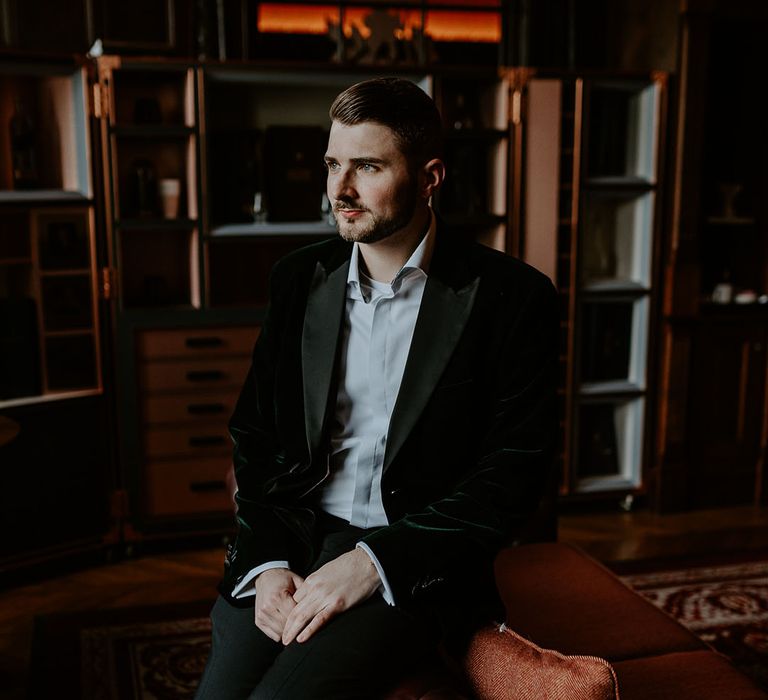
[137,327,259,360]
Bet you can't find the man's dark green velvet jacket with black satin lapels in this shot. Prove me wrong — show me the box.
[220,228,559,607]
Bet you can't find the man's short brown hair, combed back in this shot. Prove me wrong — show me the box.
[329,78,443,165]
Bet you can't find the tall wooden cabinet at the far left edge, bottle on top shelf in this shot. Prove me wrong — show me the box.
[0,58,115,568]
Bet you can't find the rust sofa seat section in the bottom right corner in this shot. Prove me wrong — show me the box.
[614,651,768,700]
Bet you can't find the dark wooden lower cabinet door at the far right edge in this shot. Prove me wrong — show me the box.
[688,321,766,507]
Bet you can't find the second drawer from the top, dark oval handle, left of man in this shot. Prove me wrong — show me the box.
[139,356,251,393]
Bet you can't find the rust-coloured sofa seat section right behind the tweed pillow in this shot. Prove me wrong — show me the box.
[496,543,707,661]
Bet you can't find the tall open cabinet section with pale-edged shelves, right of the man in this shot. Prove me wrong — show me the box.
[511,70,667,498]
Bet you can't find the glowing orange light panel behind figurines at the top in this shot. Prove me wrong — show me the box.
[258,3,501,43]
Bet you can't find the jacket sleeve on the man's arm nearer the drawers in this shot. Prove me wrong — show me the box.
[219,265,314,600]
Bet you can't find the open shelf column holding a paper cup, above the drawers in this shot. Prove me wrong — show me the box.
[96,57,202,309]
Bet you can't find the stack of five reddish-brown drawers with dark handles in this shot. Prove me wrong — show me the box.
[137,328,257,517]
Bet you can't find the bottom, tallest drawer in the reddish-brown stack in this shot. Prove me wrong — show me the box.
[145,458,234,515]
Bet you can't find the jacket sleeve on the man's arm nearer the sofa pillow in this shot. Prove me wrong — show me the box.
[363,281,559,605]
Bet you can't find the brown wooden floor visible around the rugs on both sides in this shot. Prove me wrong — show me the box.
[0,507,768,700]
